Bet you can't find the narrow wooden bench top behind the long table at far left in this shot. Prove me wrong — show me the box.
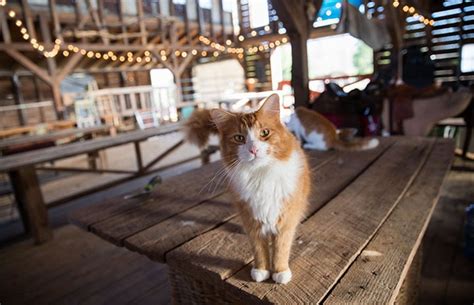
[0,126,110,155]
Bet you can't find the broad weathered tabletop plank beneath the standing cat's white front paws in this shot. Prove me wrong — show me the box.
[227,138,432,304]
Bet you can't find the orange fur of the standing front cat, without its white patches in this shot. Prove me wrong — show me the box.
[212,96,311,283]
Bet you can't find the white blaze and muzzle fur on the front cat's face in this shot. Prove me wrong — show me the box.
[237,128,273,167]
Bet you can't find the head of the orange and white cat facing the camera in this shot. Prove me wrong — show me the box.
[211,94,294,167]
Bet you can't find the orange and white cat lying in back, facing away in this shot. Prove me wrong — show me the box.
[287,107,379,150]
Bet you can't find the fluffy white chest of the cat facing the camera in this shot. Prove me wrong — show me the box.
[232,152,302,235]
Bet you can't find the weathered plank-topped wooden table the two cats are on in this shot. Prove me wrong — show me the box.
[70,137,454,304]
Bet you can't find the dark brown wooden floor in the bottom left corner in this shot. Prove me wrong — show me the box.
[0,225,170,305]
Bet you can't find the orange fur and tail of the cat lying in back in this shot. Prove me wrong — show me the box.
[295,107,378,150]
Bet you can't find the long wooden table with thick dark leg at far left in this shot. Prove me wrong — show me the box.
[0,123,189,243]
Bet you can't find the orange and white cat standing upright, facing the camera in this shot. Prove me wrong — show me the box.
[211,95,310,284]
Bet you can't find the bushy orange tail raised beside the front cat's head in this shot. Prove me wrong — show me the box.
[184,109,218,149]
